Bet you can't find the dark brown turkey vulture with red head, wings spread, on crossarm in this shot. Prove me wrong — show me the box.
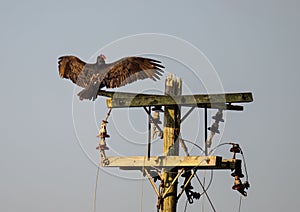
[58,54,164,100]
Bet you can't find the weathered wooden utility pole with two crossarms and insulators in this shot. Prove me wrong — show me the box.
[98,78,253,212]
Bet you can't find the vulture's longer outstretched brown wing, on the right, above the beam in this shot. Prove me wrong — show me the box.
[102,57,164,88]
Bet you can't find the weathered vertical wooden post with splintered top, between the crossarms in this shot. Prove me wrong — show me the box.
[161,74,182,212]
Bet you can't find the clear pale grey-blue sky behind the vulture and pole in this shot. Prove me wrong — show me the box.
[0,0,300,212]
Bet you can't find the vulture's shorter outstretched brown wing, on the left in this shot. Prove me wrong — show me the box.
[58,56,87,87]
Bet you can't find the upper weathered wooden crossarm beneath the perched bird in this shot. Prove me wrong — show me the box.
[106,92,253,110]
